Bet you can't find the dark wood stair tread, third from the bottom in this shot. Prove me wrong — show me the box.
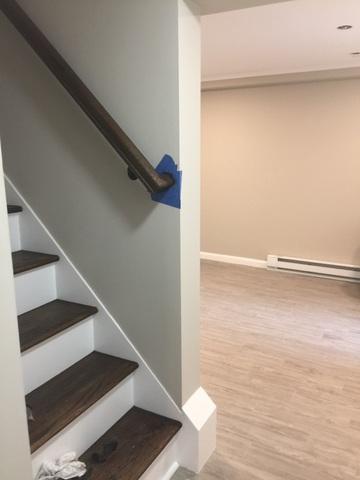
[18,300,98,352]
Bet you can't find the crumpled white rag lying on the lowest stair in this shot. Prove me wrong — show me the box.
[35,452,86,480]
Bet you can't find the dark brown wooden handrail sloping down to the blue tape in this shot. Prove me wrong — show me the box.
[0,0,175,193]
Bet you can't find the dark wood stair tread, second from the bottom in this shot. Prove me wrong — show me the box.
[26,352,138,452]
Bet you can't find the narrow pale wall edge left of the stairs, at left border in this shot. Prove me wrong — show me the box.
[0,147,32,480]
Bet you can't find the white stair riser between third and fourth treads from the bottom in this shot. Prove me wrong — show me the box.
[15,265,56,315]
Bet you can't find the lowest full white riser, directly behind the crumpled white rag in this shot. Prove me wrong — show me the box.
[32,376,134,474]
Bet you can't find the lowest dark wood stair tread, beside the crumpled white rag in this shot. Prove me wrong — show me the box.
[80,407,181,480]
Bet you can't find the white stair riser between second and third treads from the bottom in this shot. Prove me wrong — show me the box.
[21,318,94,394]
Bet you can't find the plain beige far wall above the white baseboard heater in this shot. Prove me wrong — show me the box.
[202,79,360,264]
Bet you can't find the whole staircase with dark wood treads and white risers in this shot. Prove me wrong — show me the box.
[8,205,182,480]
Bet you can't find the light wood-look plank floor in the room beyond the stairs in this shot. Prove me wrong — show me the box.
[175,262,360,480]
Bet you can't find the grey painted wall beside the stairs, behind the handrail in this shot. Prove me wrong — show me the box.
[0,0,200,405]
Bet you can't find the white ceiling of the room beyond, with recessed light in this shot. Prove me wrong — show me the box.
[202,0,360,81]
